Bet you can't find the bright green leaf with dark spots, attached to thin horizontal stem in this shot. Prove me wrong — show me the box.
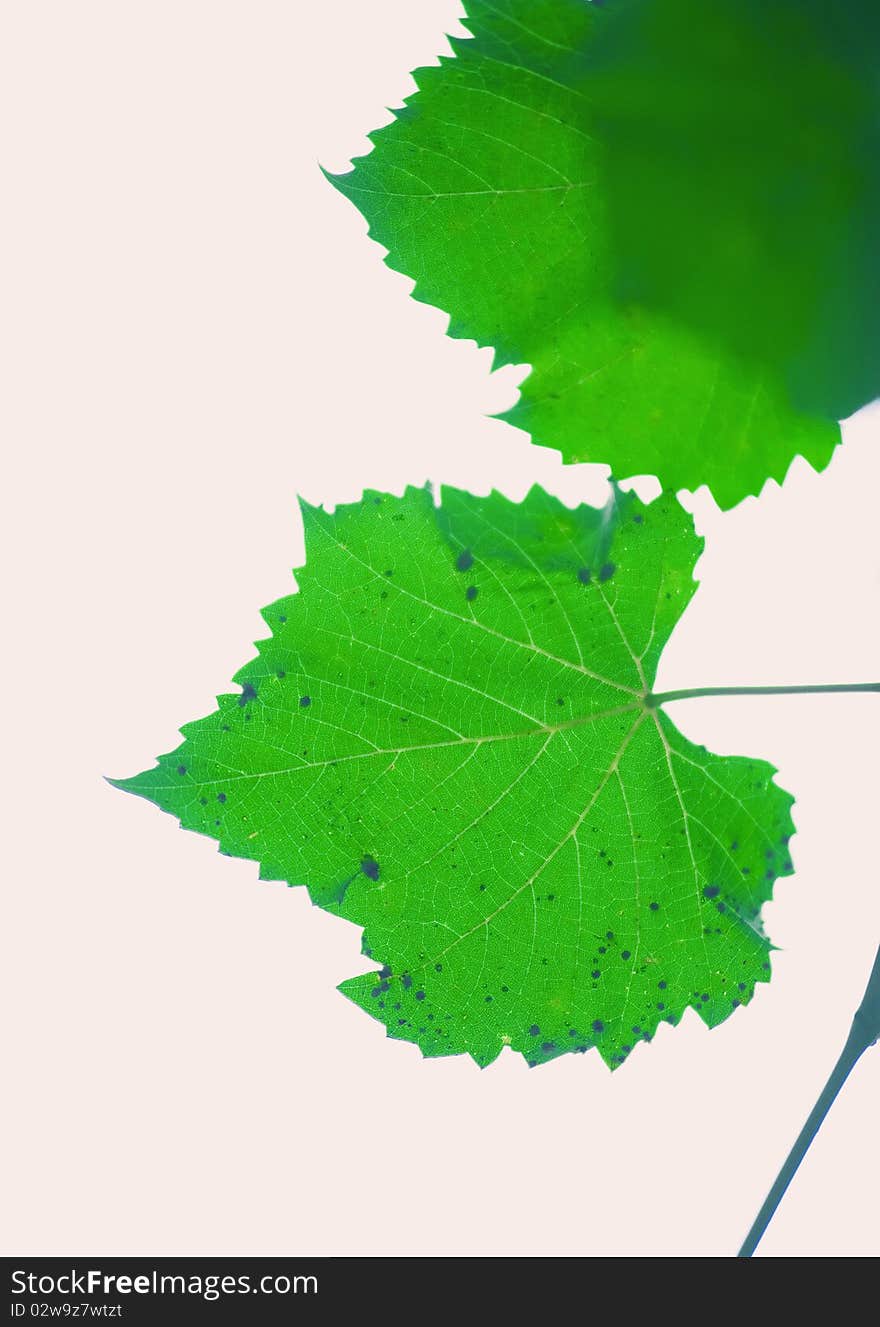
[117,488,792,1066]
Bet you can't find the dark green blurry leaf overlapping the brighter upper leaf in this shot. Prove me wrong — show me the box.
[578,0,880,419]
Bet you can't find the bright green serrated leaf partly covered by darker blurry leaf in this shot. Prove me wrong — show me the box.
[328,0,839,507]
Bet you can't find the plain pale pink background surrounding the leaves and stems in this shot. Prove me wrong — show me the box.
[0,0,880,1255]
